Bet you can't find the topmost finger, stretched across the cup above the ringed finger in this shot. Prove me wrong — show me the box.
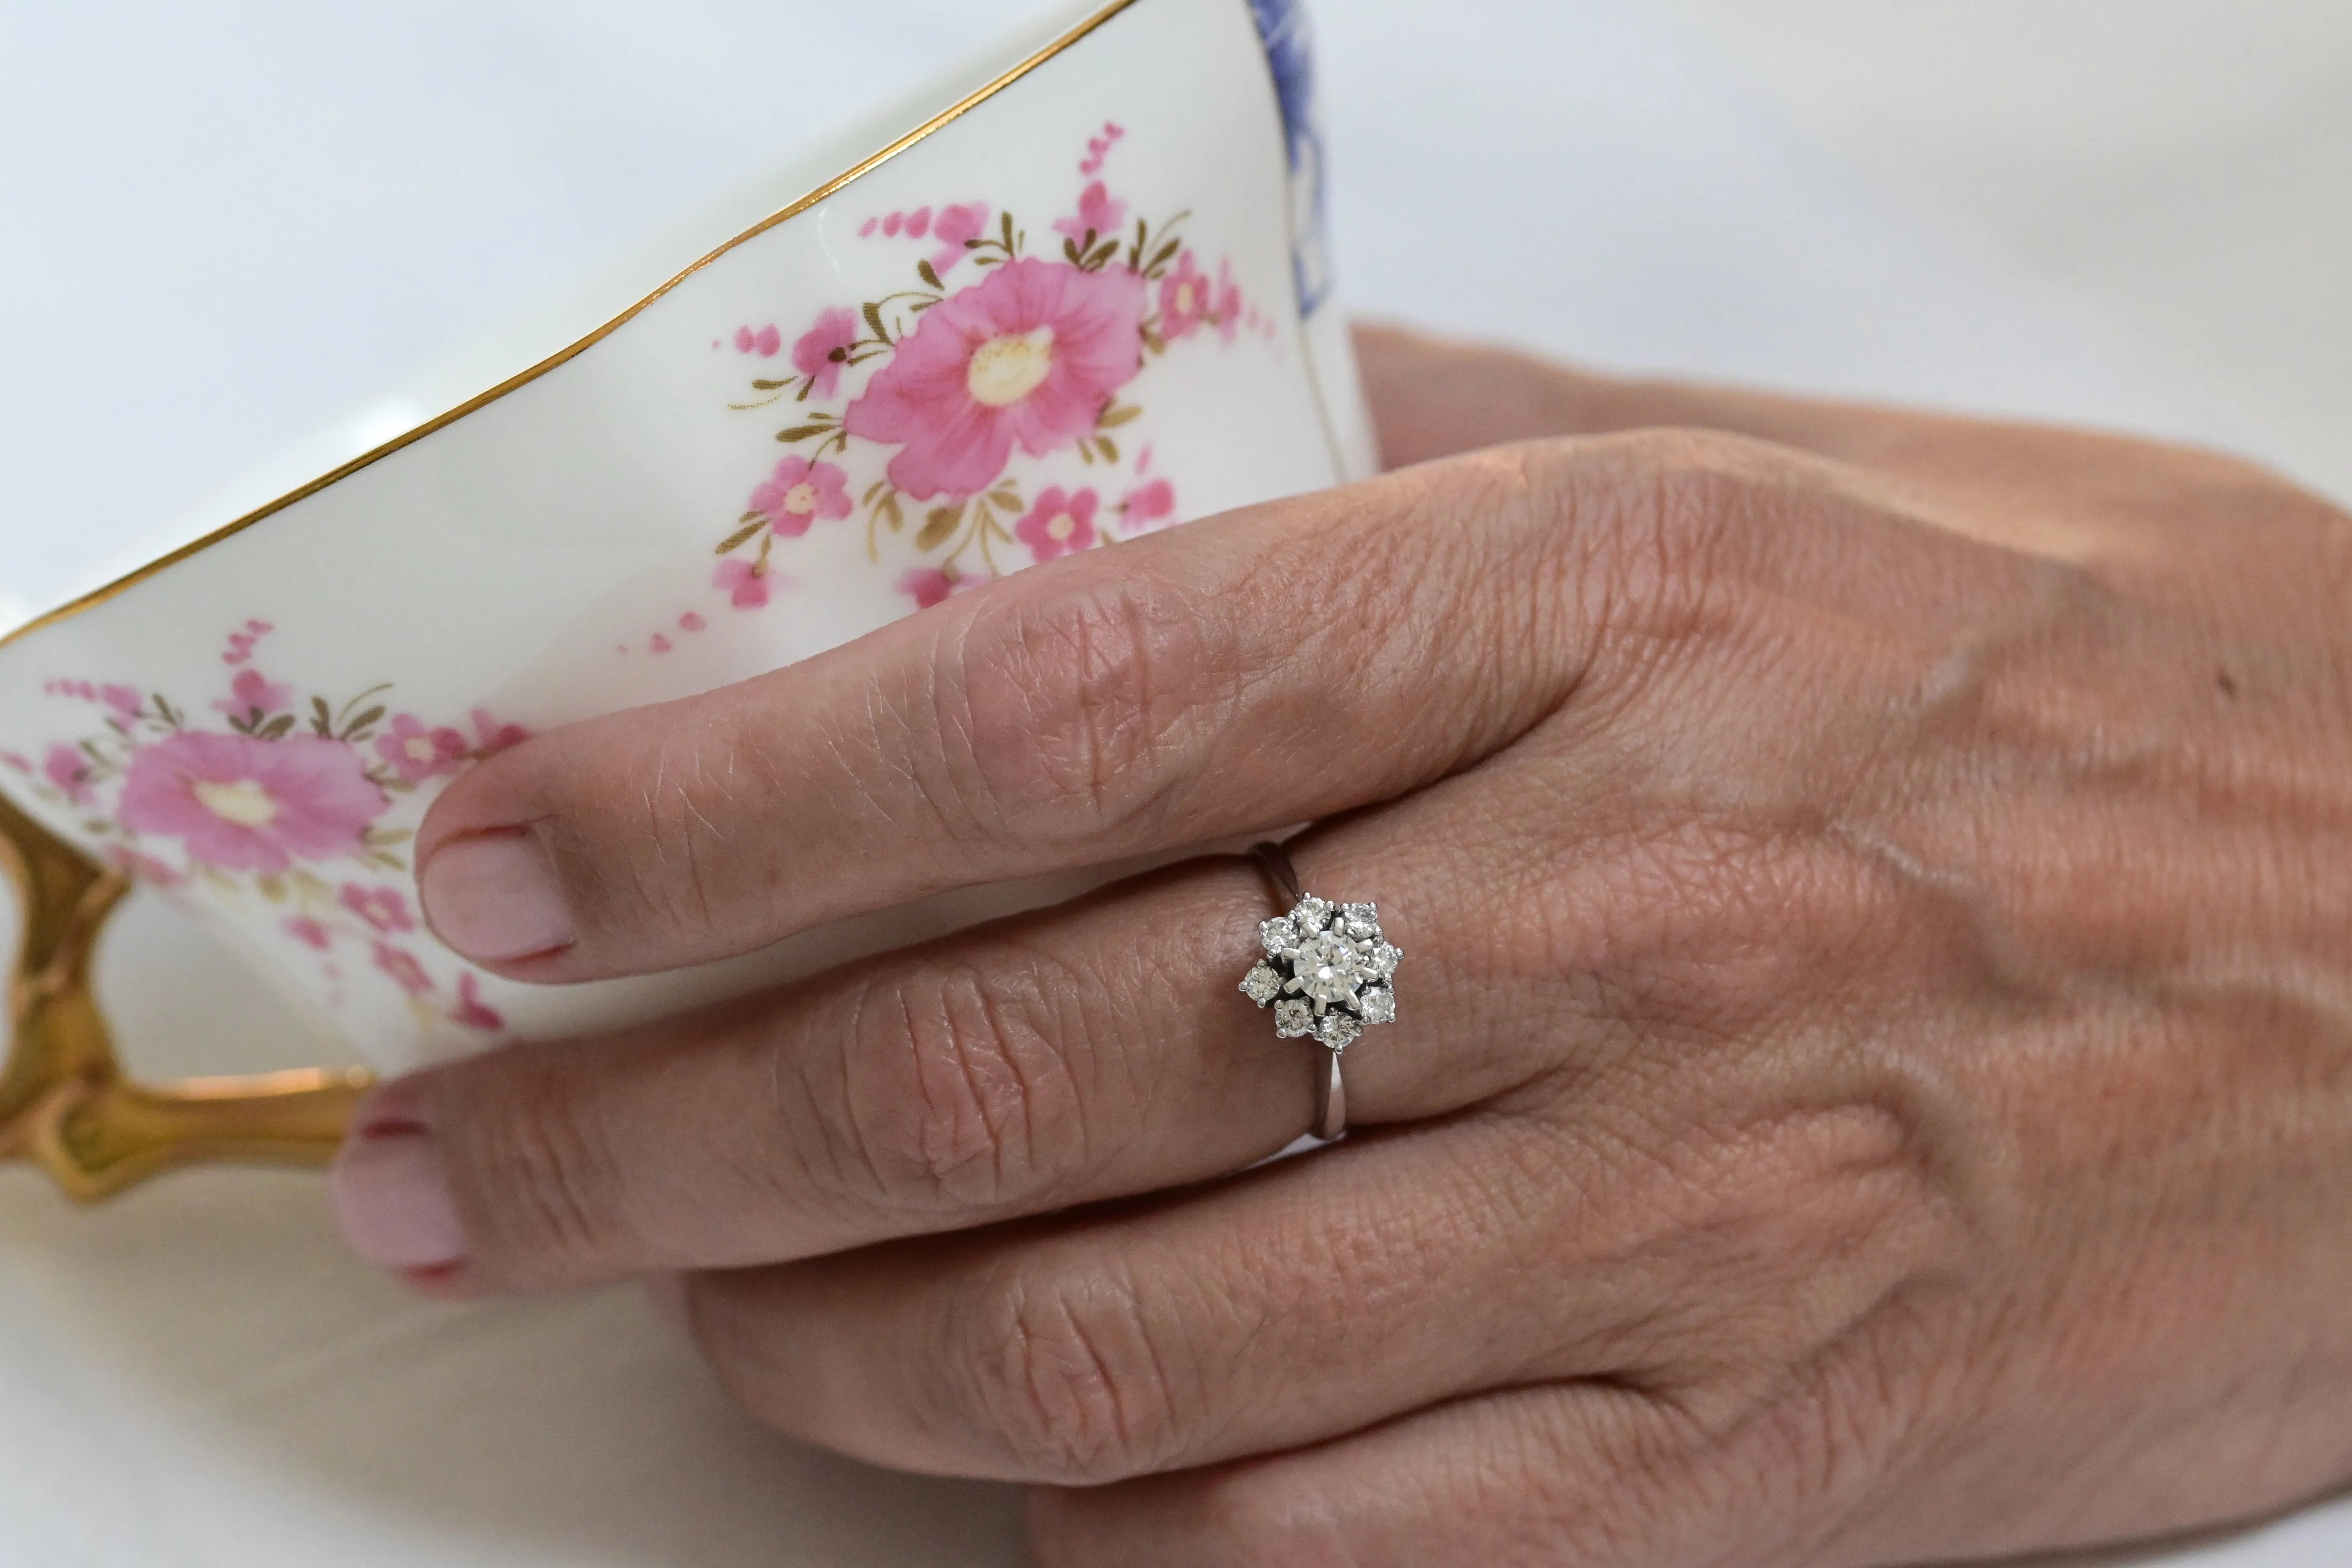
[419,456,1578,980]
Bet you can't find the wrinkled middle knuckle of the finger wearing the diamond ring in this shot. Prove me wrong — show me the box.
[835,954,1086,1213]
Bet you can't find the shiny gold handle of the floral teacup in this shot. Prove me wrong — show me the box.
[0,795,369,1203]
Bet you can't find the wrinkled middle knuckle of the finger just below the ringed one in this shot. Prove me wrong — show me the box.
[957,1267,1179,1486]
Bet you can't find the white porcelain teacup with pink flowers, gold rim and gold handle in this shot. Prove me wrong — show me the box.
[0,0,1374,1197]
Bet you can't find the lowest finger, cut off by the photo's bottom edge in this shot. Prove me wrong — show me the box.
[1030,1382,1750,1568]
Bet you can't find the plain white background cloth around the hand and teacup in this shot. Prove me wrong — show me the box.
[0,0,2352,1568]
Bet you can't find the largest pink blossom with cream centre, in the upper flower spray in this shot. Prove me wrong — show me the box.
[842,259,1143,501]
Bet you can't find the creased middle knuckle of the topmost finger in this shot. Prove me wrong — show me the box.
[941,583,1216,844]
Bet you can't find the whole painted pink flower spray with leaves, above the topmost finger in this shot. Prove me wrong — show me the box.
[696,122,1277,625]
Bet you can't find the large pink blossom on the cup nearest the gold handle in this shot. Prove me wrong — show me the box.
[120,731,388,877]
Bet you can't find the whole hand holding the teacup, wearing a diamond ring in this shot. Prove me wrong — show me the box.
[336,334,2352,1568]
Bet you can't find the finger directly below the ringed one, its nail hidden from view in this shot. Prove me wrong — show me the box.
[687,1043,1910,1486]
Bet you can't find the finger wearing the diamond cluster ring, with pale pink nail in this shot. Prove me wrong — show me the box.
[334,856,1524,1293]
